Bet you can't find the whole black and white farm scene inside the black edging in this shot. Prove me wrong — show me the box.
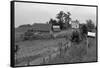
[11,1,98,67]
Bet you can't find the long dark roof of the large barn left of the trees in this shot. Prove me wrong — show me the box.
[32,23,51,31]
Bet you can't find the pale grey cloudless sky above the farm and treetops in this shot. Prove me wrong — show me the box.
[15,2,96,27]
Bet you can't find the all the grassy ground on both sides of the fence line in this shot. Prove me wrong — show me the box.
[15,31,97,66]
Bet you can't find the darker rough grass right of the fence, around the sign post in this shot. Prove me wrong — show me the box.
[47,38,97,64]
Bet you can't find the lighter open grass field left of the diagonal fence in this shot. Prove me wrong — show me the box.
[16,38,65,66]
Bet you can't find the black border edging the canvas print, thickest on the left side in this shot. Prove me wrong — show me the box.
[10,1,98,67]
